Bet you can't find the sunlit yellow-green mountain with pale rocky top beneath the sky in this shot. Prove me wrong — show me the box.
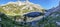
[0,1,45,16]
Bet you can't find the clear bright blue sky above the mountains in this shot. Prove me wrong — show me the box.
[0,0,60,9]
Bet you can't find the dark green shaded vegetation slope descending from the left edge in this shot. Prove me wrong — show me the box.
[0,14,22,27]
